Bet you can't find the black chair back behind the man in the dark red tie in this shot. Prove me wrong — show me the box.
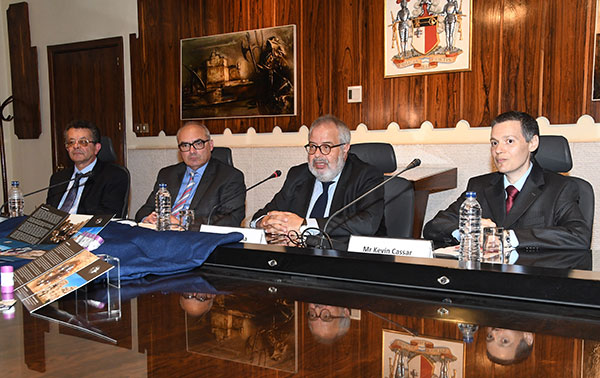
[535,135,595,227]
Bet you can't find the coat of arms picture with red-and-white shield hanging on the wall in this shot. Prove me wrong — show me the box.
[384,0,471,77]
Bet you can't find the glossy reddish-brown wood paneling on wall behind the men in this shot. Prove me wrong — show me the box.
[130,0,600,135]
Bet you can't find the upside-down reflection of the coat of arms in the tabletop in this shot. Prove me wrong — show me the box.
[382,330,464,378]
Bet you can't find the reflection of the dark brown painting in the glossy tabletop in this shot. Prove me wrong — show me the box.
[186,295,297,372]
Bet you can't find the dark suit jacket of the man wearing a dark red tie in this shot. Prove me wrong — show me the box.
[423,163,592,249]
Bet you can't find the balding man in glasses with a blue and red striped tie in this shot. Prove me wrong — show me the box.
[135,121,246,227]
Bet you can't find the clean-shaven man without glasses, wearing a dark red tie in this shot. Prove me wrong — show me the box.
[423,112,592,249]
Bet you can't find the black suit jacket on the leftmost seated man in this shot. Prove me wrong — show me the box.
[46,160,129,216]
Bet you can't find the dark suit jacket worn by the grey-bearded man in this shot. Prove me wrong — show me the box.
[252,154,384,249]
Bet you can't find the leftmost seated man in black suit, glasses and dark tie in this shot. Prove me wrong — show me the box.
[46,121,129,216]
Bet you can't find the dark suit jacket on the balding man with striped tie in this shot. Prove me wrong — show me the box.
[135,158,246,227]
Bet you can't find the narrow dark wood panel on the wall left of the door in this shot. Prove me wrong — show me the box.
[6,2,42,139]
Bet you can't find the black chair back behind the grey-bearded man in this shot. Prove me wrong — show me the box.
[350,143,415,238]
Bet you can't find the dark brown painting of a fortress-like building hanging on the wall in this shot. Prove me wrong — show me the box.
[181,25,296,119]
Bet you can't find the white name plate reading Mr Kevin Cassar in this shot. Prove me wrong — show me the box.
[348,235,433,258]
